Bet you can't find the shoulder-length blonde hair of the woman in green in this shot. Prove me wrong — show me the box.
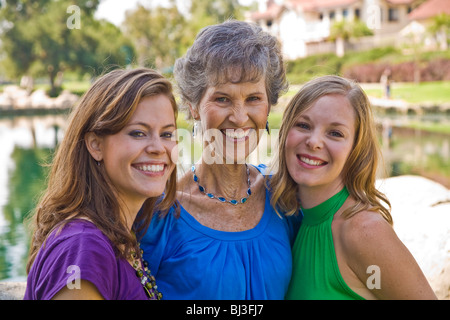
[268,75,393,225]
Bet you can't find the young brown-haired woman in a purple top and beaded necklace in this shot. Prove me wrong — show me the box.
[25,68,177,300]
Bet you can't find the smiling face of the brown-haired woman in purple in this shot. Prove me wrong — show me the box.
[89,94,176,203]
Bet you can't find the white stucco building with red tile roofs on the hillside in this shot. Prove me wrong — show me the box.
[249,0,423,59]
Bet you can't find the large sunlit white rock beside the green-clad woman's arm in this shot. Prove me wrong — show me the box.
[378,176,450,299]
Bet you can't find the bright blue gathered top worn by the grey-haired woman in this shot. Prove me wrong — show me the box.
[141,167,301,300]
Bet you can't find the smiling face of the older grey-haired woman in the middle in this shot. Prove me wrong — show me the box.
[191,78,269,163]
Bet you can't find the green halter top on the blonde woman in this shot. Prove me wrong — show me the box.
[286,187,364,300]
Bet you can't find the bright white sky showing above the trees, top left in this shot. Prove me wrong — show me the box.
[95,0,253,26]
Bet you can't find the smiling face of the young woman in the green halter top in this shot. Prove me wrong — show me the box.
[285,94,356,192]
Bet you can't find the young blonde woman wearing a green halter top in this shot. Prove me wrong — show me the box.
[270,76,436,299]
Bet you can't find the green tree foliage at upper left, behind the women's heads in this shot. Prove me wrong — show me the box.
[0,0,244,86]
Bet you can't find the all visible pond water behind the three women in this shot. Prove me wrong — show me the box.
[0,115,450,281]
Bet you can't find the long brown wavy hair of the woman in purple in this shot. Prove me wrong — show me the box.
[27,68,178,272]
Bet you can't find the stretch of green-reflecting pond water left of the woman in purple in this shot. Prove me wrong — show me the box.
[0,115,65,281]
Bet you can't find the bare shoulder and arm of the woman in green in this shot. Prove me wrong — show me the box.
[345,211,437,300]
